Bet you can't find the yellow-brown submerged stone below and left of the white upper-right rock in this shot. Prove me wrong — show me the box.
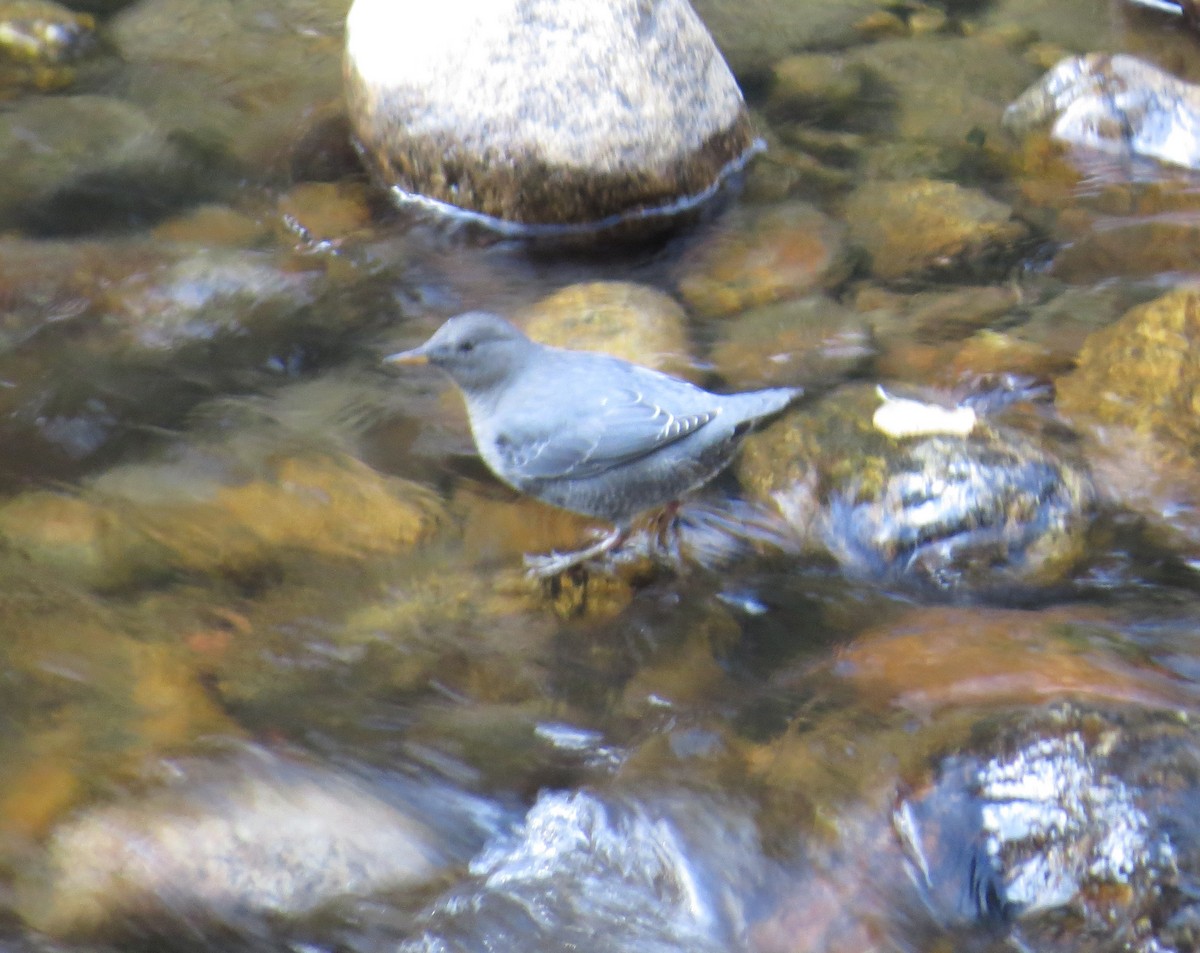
[845,179,1030,281]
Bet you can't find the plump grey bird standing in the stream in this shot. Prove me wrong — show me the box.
[385,311,802,576]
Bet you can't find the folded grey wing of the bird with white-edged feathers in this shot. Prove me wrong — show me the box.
[496,385,719,480]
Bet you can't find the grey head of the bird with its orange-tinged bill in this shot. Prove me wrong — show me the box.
[384,311,536,394]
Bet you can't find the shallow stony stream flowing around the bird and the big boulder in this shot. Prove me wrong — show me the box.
[0,0,1200,953]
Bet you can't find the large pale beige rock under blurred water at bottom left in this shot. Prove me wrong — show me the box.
[18,751,448,937]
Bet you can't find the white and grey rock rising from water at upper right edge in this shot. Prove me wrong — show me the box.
[1004,53,1200,169]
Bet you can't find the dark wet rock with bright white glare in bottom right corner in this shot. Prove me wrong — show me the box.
[896,706,1200,951]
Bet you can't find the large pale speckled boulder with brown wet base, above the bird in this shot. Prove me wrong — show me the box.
[346,0,754,234]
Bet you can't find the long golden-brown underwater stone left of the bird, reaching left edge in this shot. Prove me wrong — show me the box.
[0,455,439,588]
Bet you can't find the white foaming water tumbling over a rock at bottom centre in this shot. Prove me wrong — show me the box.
[401,791,763,953]
